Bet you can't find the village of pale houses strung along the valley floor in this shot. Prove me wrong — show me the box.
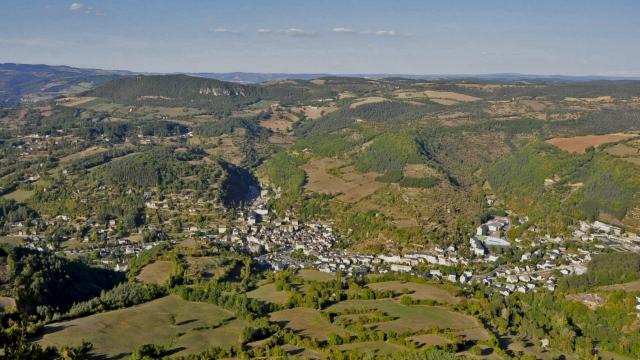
[2,183,640,296]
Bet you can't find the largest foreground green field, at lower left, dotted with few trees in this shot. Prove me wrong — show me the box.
[37,295,246,358]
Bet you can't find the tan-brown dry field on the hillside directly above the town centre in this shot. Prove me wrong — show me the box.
[303,158,383,203]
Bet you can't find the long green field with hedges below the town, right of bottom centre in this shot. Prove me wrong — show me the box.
[328,300,480,332]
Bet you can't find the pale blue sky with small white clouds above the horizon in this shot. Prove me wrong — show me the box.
[0,0,640,76]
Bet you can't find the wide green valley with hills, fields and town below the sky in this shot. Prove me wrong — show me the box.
[0,70,640,359]
